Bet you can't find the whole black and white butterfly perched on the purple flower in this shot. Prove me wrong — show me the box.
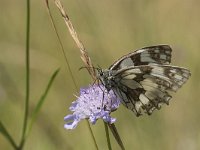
[98,45,191,116]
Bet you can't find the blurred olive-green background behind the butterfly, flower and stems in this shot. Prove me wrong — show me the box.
[0,0,200,150]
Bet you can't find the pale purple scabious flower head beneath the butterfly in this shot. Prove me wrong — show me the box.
[64,84,120,129]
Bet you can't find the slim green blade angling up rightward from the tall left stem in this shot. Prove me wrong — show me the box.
[26,69,60,136]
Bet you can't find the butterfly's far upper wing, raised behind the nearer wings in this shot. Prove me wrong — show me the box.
[109,45,172,70]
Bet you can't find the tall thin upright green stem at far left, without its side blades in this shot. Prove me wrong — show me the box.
[19,0,30,149]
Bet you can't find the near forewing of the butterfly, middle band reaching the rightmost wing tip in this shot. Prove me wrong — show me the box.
[115,64,190,92]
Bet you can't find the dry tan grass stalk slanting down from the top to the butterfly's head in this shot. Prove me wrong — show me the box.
[54,0,96,80]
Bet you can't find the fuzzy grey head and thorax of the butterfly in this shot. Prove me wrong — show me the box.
[97,69,116,91]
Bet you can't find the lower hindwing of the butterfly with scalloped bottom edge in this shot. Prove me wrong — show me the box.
[114,85,171,116]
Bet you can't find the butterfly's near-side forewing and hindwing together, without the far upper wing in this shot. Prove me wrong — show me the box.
[113,64,190,116]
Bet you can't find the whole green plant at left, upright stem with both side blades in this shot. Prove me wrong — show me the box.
[0,0,59,150]
